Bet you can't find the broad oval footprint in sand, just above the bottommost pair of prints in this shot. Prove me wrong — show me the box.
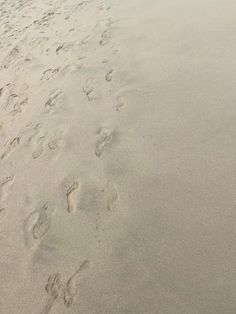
[24,204,53,247]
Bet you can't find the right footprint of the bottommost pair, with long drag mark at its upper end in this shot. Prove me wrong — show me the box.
[64,260,89,307]
